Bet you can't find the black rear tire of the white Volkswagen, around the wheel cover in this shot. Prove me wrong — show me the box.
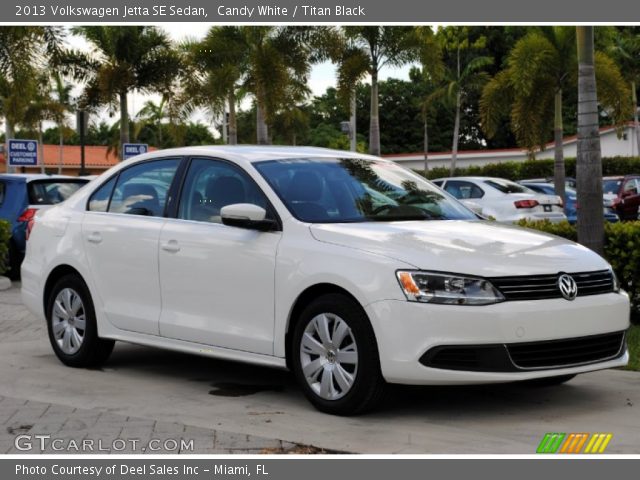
[46,274,115,368]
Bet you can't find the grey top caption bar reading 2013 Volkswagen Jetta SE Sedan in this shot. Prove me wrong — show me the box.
[0,0,640,24]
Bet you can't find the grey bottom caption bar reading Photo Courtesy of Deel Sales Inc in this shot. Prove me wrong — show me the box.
[0,457,640,480]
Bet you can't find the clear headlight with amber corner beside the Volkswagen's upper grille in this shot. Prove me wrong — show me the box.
[396,270,504,305]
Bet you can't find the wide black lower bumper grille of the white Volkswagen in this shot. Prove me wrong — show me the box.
[420,332,625,372]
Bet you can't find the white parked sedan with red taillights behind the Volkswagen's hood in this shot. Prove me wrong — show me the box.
[433,177,567,223]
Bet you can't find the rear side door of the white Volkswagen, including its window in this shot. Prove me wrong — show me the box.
[82,158,181,335]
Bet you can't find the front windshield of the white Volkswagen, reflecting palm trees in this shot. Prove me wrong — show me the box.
[254,158,478,223]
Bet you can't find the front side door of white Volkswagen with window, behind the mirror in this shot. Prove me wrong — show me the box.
[159,158,281,355]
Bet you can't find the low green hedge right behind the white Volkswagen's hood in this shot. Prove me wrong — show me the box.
[518,220,640,323]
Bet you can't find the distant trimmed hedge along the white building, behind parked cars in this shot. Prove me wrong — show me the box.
[419,157,640,180]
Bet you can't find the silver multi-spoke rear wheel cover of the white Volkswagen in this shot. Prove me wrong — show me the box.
[51,288,87,355]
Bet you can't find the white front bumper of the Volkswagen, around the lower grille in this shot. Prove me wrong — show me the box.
[366,293,629,385]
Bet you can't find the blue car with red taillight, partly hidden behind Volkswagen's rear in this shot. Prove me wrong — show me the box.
[0,174,89,280]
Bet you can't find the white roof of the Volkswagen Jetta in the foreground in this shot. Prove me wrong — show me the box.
[122,145,384,164]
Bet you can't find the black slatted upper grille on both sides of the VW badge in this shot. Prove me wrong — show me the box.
[489,270,613,300]
